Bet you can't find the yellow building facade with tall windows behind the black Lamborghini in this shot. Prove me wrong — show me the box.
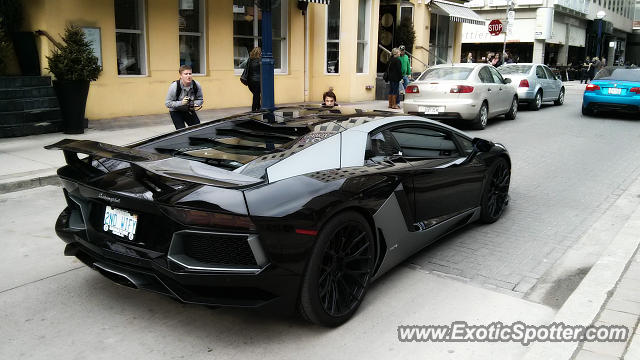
[18,0,482,121]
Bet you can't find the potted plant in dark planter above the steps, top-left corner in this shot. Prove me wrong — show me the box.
[0,0,40,76]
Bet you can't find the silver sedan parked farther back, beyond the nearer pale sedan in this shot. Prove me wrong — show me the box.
[498,63,565,110]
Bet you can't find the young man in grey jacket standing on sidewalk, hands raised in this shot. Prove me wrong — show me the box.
[164,65,203,130]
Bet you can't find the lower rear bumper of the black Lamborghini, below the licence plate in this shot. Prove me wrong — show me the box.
[56,207,301,313]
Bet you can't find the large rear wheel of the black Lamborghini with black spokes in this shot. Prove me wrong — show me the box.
[299,211,375,327]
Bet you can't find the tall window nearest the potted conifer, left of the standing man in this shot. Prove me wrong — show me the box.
[113,0,147,75]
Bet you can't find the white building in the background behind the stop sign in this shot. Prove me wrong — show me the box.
[462,0,634,66]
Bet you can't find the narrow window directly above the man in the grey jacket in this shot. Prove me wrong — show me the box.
[178,0,206,74]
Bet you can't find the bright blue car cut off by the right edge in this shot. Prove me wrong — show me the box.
[582,67,640,115]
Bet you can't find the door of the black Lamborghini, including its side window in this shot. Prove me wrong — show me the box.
[390,124,485,229]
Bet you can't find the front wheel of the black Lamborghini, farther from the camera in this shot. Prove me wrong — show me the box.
[480,157,511,224]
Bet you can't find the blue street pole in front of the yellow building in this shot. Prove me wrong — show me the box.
[260,0,276,110]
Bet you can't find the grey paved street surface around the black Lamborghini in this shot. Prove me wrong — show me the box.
[0,88,640,359]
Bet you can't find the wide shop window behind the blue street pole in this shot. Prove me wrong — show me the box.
[233,0,288,74]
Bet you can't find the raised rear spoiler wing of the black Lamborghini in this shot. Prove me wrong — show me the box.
[44,139,262,187]
